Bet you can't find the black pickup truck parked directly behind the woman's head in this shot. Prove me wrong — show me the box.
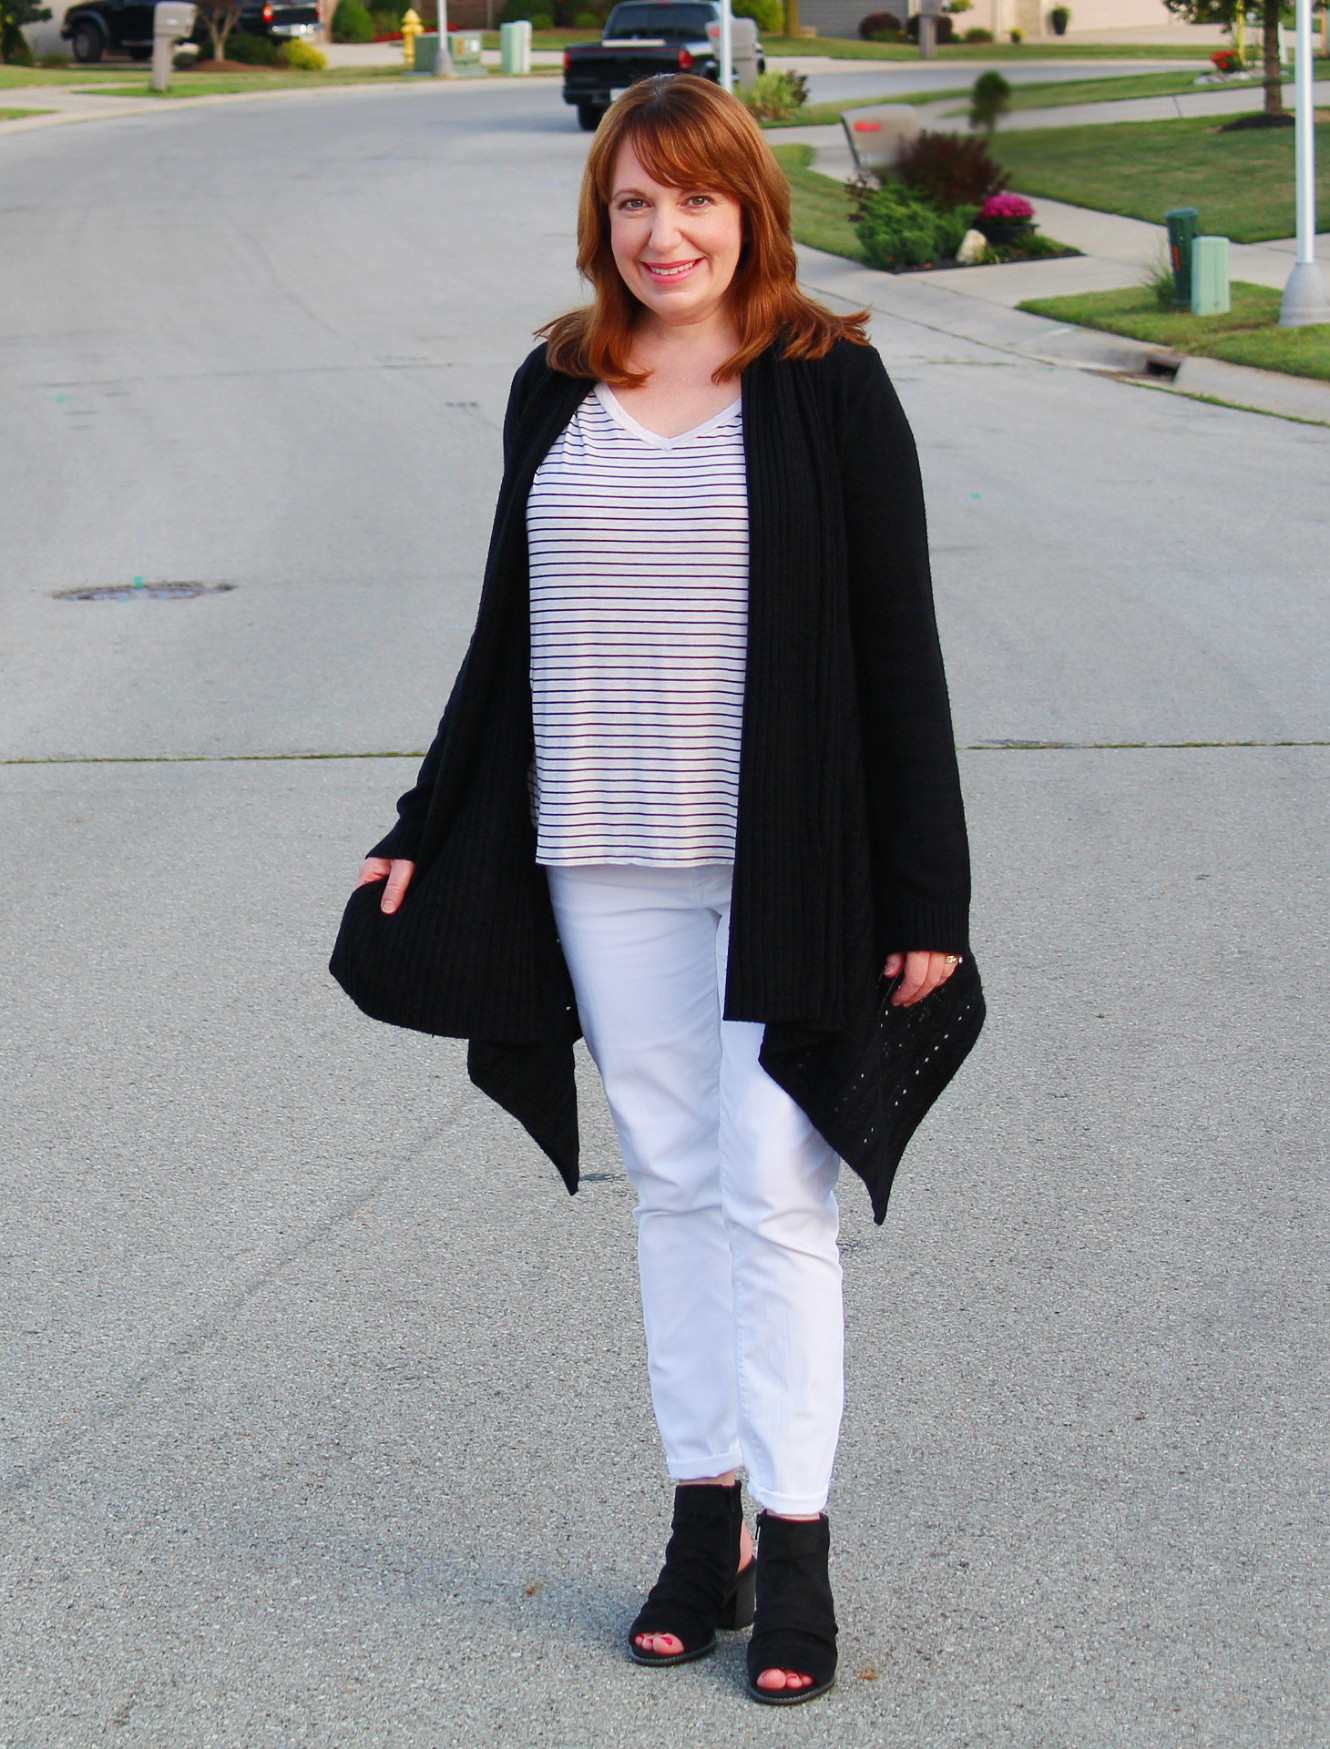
[564,0,767,133]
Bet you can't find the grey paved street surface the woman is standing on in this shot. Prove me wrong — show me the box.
[0,87,1330,1749]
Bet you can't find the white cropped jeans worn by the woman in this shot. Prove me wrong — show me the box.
[548,864,844,1513]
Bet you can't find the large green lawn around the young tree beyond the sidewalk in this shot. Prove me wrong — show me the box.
[992,111,1330,243]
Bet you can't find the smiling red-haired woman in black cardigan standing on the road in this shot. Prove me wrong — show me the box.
[334,75,968,1705]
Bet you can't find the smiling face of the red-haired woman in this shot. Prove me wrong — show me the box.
[609,143,744,325]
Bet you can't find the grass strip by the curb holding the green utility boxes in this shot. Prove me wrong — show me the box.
[1020,280,1330,381]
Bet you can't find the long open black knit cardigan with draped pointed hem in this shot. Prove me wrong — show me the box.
[333,341,970,1217]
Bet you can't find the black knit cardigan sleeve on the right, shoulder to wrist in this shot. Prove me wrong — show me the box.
[838,346,970,953]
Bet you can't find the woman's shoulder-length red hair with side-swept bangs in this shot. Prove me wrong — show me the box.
[537,73,868,388]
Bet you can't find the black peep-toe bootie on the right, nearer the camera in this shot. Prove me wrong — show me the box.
[747,1513,837,1707]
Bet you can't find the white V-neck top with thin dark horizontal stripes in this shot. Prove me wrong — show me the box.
[527,383,747,868]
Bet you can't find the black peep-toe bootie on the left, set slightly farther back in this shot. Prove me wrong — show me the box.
[628,1481,756,1663]
